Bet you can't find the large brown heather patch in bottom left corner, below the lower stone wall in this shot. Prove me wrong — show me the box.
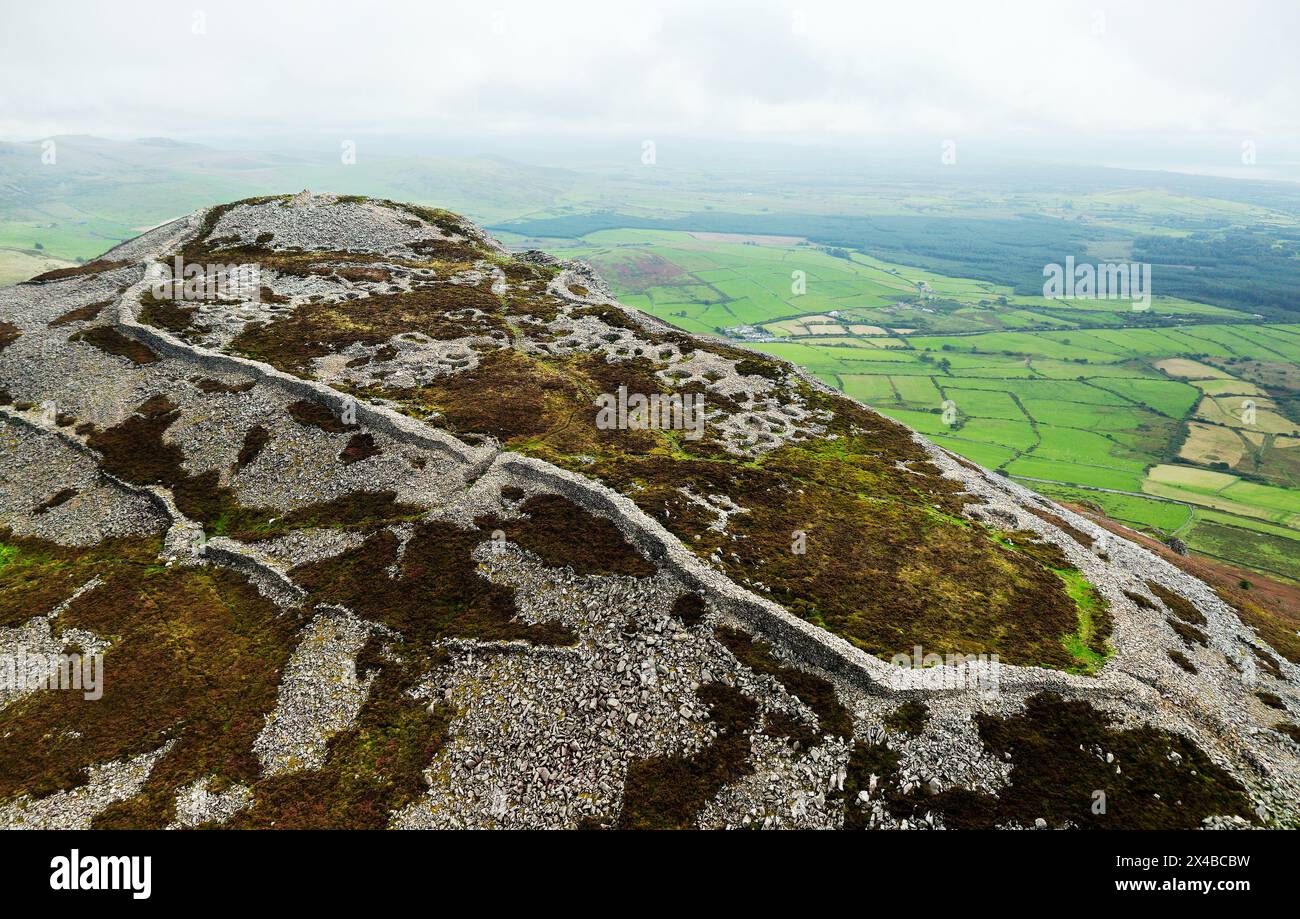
[0,539,295,825]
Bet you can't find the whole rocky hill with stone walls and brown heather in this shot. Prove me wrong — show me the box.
[0,192,1300,829]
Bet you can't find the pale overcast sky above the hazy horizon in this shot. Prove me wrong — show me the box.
[0,0,1300,163]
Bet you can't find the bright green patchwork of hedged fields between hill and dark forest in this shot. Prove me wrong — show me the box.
[508,230,1300,578]
